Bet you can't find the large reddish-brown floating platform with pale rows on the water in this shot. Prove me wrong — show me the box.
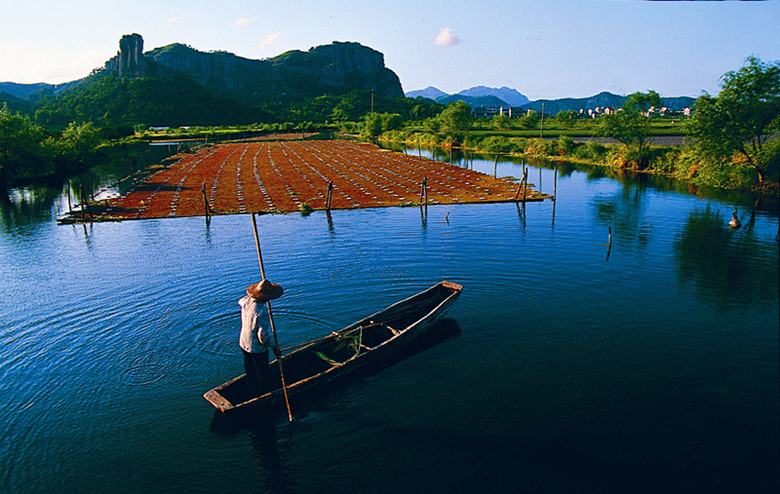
[60,140,550,223]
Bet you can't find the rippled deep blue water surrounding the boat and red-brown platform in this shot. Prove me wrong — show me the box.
[0,145,780,492]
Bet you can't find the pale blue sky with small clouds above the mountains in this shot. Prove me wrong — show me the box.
[0,0,780,99]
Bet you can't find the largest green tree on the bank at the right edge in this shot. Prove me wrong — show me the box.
[687,57,780,183]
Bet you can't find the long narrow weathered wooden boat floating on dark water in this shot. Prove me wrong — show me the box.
[203,281,463,413]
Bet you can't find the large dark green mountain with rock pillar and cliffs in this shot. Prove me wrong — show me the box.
[6,34,411,127]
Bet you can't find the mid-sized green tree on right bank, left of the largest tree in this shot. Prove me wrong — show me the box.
[599,91,661,170]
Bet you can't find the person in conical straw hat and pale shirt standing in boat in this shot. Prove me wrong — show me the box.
[238,280,284,394]
